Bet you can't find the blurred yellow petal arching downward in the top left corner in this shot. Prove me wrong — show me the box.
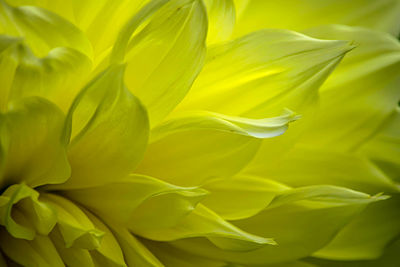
[0,1,93,58]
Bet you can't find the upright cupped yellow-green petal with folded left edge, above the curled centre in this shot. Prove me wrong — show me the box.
[50,65,149,189]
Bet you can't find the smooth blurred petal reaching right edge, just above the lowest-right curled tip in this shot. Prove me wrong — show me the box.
[245,147,400,194]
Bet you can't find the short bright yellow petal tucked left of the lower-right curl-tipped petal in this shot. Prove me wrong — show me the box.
[202,175,290,220]
